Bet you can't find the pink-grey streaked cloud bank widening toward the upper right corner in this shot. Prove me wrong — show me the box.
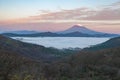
[23,1,120,21]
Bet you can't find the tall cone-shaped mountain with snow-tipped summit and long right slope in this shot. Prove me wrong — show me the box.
[57,25,118,37]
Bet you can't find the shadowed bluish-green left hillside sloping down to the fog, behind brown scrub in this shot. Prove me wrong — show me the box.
[0,35,76,61]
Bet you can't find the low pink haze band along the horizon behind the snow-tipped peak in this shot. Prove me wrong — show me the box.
[0,21,120,34]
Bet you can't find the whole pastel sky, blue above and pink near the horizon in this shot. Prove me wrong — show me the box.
[0,0,120,34]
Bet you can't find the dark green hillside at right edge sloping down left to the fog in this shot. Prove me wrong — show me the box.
[84,37,120,51]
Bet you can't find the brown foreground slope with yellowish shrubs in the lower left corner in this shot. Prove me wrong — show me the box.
[0,49,43,80]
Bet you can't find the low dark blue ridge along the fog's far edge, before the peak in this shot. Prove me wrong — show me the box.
[2,32,107,37]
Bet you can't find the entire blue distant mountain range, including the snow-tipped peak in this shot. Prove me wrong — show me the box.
[3,25,120,37]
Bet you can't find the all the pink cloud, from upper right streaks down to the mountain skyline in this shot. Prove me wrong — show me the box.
[0,2,120,33]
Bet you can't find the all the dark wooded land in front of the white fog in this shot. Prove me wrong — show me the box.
[0,36,120,80]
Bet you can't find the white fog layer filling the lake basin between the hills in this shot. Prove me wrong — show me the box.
[12,37,109,49]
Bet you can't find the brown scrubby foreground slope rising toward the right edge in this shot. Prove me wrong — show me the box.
[46,47,120,80]
